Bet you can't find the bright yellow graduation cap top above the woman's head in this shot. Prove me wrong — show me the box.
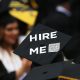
[9,9,38,26]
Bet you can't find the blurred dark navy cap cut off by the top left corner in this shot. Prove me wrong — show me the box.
[0,0,11,14]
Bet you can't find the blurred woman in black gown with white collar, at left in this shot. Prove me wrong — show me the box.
[0,12,32,80]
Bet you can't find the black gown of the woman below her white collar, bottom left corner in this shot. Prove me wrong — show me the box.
[0,61,16,80]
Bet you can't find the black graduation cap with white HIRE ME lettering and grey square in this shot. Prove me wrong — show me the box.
[14,24,71,65]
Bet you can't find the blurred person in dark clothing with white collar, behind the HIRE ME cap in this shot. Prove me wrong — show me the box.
[44,0,72,35]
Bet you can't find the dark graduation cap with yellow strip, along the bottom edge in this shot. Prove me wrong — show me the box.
[24,61,80,80]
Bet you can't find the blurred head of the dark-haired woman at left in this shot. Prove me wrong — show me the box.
[0,13,19,48]
